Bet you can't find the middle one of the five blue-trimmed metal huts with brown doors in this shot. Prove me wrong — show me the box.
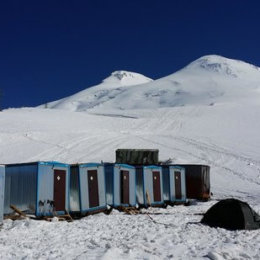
[104,163,136,208]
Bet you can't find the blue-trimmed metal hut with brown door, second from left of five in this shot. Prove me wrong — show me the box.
[70,163,107,215]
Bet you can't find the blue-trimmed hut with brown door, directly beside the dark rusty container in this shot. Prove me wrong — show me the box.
[161,165,186,204]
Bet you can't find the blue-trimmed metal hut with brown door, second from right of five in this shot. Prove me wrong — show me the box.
[136,165,164,207]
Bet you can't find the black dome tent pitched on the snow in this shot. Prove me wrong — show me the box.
[201,199,260,230]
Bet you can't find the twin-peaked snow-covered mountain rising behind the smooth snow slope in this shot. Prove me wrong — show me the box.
[41,55,260,111]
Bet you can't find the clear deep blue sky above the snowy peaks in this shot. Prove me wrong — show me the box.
[0,0,260,108]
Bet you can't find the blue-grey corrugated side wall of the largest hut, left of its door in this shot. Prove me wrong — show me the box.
[4,163,38,214]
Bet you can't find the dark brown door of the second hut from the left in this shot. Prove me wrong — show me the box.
[88,170,99,208]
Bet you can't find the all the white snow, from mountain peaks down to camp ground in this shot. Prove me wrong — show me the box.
[0,55,260,259]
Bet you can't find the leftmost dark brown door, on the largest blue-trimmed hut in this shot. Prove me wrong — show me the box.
[53,170,66,211]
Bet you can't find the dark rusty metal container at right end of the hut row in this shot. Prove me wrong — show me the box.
[176,164,211,200]
